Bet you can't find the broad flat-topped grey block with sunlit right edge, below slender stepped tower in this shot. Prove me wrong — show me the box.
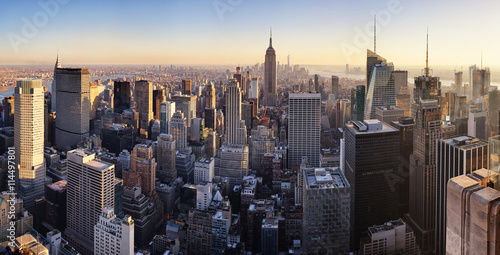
[214,144,248,188]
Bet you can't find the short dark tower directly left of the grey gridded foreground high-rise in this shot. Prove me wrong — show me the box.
[45,180,68,230]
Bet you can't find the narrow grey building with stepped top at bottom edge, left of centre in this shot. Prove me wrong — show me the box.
[212,200,232,254]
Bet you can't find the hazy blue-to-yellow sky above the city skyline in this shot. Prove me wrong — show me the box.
[0,0,500,67]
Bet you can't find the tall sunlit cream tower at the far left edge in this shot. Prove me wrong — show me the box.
[14,80,46,214]
